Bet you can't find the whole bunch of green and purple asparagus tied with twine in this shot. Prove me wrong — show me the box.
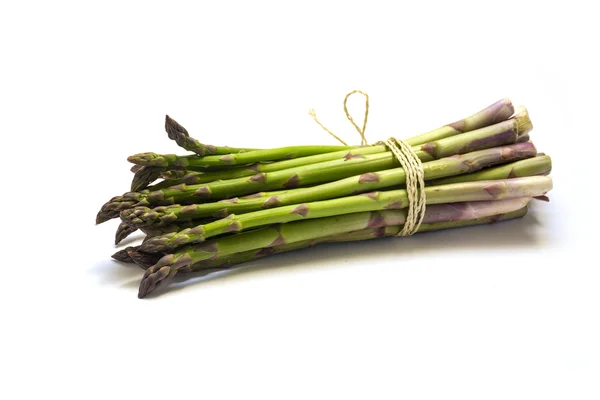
[96,99,552,297]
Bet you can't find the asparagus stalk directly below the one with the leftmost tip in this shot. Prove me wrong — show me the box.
[121,142,536,227]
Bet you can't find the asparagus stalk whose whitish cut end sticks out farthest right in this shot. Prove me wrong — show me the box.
[140,177,552,253]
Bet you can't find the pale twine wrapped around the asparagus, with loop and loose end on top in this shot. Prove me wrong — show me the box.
[308,90,427,236]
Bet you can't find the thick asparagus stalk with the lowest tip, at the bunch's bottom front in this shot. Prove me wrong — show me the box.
[138,198,529,298]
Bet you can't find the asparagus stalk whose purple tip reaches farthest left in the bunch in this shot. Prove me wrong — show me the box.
[96,111,532,223]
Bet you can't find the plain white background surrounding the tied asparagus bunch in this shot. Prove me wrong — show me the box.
[0,1,600,399]
